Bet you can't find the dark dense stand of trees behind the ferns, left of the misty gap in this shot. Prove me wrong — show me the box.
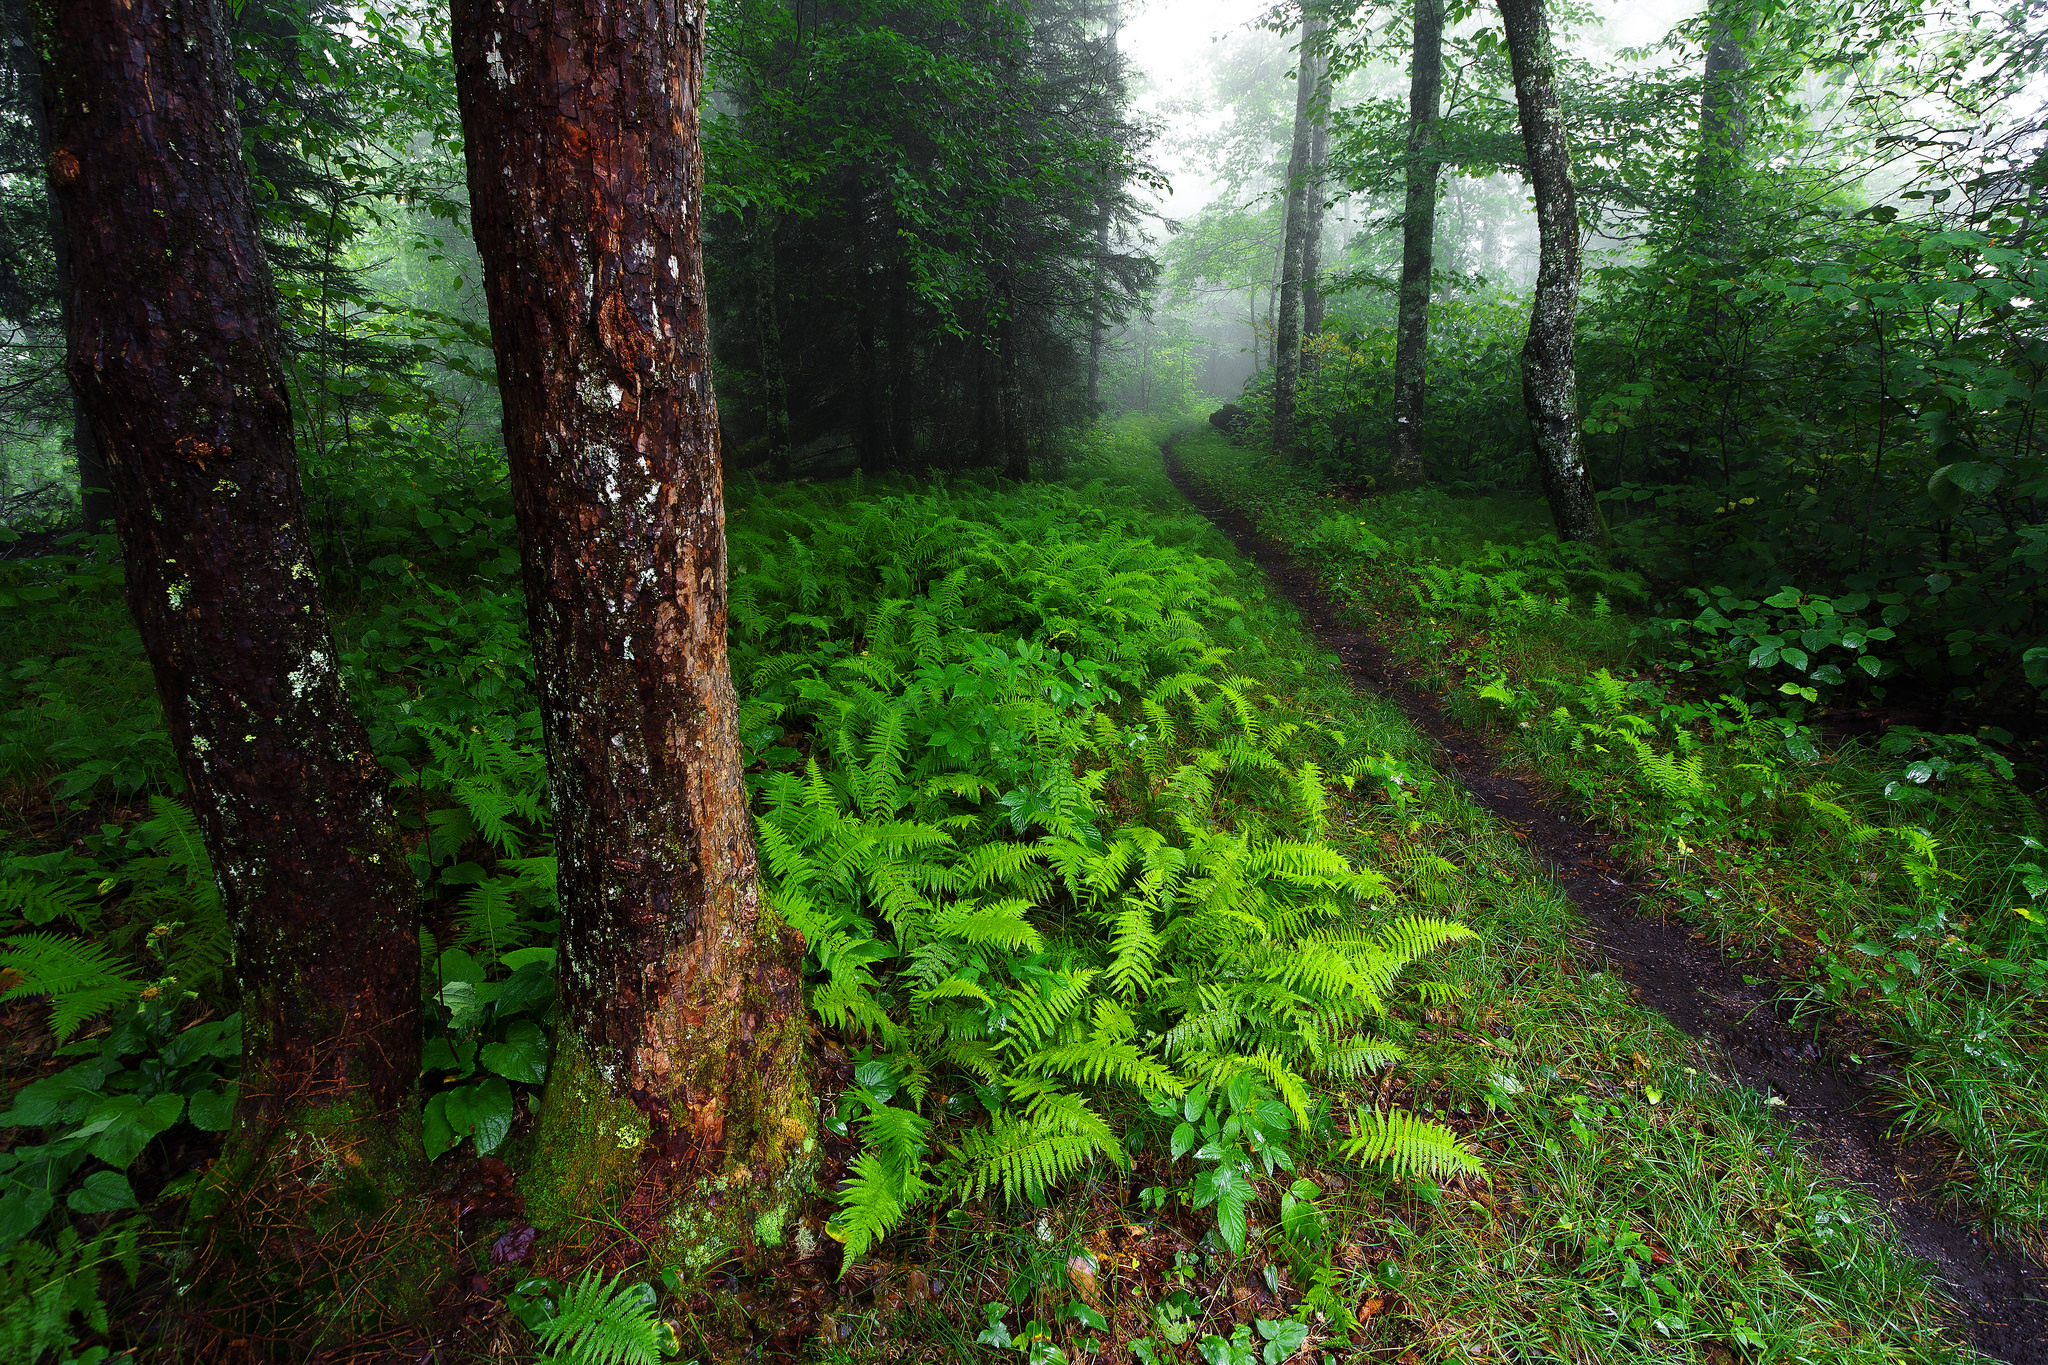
[705,0,1153,477]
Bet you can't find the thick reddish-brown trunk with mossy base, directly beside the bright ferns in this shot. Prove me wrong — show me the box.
[453,0,815,1265]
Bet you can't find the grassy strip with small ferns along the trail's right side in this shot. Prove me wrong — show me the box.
[1178,423,2048,1254]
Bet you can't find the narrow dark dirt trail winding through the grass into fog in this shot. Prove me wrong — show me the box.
[1161,438,2048,1365]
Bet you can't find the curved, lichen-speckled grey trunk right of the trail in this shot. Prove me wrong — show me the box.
[1499,0,1608,542]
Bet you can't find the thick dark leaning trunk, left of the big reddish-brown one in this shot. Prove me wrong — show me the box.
[37,0,420,1146]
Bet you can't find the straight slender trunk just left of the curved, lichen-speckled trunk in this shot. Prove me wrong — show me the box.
[1389,0,1444,487]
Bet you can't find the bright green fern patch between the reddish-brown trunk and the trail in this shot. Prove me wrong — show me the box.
[733,493,1470,1254]
